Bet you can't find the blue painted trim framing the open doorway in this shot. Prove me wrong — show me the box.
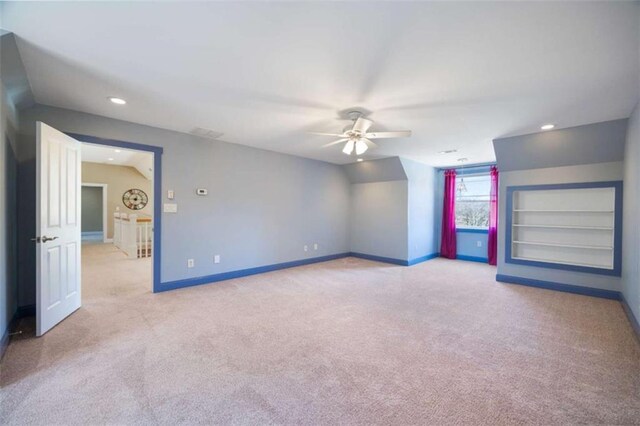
[67,133,163,293]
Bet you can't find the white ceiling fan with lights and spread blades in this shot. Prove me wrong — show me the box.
[311,111,411,155]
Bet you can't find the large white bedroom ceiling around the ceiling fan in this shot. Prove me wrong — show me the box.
[2,2,640,166]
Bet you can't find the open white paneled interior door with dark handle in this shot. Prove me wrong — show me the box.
[34,122,82,336]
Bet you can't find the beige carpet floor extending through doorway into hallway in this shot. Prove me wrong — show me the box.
[0,245,640,425]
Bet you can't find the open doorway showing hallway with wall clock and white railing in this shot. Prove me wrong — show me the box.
[80,142,155,294]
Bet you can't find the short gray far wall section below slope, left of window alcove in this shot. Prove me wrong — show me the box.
[351,180,409,260]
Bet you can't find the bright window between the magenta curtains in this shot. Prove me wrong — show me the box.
[456,173,491,229]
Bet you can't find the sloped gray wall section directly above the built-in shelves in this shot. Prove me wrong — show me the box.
[493,118,627,172]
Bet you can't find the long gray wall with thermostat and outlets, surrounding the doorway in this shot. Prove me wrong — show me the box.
[19,105,350,306]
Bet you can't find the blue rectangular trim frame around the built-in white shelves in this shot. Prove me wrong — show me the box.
[505,181,623,277]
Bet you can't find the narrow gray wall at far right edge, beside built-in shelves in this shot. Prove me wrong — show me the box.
[622,104,640,321]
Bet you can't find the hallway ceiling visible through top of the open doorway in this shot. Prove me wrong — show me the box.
[80,143,153,180]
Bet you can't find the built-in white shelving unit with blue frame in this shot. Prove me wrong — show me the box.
[506,182,622,274]
